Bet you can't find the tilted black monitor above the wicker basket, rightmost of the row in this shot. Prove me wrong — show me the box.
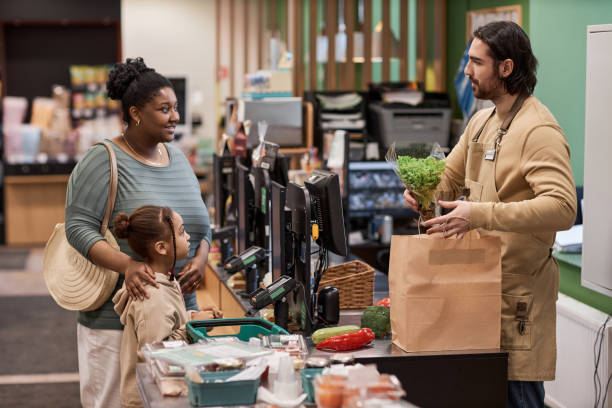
[304,170,348,256]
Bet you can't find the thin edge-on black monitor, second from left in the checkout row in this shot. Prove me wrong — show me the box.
[236,164,255,254]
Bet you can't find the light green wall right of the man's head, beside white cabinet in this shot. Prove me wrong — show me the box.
[530,0,612,185]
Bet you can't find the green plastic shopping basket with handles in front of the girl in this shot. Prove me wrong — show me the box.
[187,317,289,343]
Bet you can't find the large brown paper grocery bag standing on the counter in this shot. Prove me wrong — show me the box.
[389,231,501,352]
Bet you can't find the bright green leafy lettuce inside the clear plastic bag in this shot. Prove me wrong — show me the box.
[397,156,446,209]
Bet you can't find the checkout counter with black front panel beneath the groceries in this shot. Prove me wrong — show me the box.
[136,255,508,408]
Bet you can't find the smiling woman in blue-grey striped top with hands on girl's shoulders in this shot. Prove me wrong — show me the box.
[66,58,210,408]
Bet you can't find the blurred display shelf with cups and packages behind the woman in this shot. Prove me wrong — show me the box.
[0,19,122,245]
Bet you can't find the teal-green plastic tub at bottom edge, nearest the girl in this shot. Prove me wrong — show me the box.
[185,371,259,407]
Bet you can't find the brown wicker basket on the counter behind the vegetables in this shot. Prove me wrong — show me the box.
[319,261,374,309]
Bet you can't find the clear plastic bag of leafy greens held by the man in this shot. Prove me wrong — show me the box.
[385,143,446,220]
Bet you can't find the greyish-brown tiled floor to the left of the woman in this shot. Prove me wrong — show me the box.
[0,247,80,407]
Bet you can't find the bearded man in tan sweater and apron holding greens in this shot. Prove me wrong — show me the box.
[404,22,577,407]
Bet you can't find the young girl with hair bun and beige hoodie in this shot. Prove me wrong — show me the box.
[113,206,223,407]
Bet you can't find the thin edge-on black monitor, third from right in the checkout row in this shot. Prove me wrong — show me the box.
[270,181,290,281]
